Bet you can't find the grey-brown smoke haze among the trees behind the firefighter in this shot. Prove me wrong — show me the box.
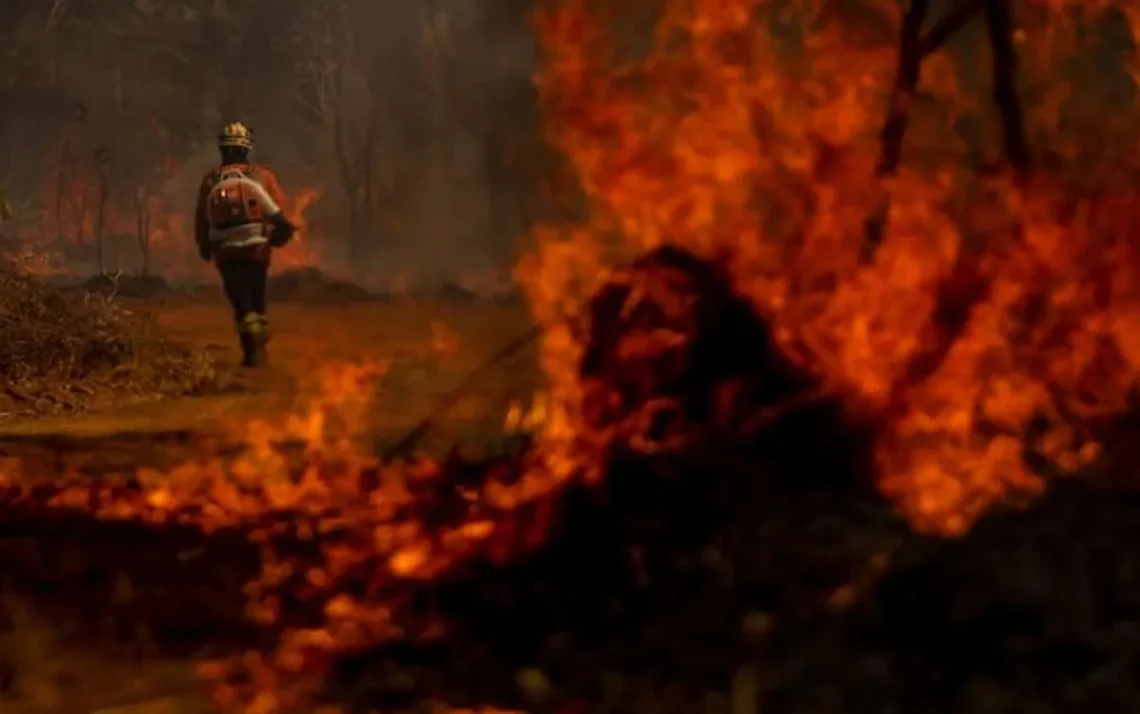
[0,0,546,282]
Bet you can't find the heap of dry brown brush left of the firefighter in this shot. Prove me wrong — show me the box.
[0,262,217,412]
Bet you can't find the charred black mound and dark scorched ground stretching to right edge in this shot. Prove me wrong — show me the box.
[326,250,1140,714]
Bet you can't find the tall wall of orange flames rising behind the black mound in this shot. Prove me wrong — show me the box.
[518,0,1140,532]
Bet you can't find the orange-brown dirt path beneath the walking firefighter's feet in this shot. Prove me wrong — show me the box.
[0,301,535,473]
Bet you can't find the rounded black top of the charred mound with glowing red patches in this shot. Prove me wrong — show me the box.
[579,248,839,452]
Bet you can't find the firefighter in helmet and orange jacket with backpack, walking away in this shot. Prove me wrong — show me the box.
[195,122,296,367]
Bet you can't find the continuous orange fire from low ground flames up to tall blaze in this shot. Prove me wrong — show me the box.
[6,0,1140,714]
